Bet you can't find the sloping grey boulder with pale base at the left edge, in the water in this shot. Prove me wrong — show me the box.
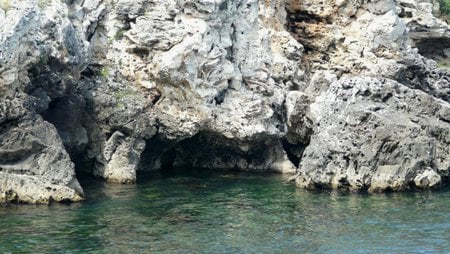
[0,118,83,203]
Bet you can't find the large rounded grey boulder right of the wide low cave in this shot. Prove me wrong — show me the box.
[297,77,450,191]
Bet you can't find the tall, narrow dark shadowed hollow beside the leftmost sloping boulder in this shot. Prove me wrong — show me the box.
[25,58,94,175]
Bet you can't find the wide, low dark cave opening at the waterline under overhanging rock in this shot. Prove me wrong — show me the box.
[137,132,305,180]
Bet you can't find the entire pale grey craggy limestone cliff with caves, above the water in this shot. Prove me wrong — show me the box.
[0,0,450,203]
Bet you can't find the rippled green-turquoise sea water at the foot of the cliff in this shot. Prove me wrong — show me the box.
[0,171,450,253]
